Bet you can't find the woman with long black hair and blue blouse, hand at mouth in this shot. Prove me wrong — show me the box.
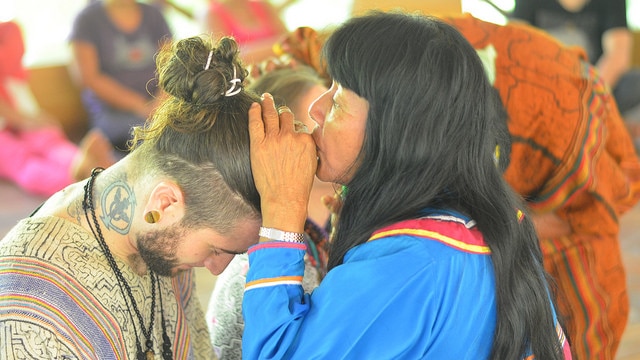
[243,12,571,359]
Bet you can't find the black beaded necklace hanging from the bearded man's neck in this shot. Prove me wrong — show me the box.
[82,168,173,360]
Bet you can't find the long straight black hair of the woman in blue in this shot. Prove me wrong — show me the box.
[323,12,562,359]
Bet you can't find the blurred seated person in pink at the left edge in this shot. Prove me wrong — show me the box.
[0,21,115,196]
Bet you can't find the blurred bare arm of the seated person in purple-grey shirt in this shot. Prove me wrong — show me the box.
[71,41,153,118]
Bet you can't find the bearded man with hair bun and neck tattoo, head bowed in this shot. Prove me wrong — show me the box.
[0,37,260,359]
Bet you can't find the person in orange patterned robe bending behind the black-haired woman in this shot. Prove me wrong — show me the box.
[275,15,640,359]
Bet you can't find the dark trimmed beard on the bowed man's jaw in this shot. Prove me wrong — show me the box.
[137,225,184,276]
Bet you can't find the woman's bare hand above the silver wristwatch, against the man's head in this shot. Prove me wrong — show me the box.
[249,94,318,233]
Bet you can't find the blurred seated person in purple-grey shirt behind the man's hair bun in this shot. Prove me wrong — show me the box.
[70,0,172,156]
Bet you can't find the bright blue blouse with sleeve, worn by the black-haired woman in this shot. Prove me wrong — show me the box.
[242,236,495,359]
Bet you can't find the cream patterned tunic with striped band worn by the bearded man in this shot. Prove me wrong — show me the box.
[0,217,213,360]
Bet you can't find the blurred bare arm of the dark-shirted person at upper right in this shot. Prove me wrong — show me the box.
[596,28,633,87]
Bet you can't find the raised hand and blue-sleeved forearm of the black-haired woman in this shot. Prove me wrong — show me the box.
[242,94,317,358]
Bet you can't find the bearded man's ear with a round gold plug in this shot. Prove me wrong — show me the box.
[144,181,185,224]
